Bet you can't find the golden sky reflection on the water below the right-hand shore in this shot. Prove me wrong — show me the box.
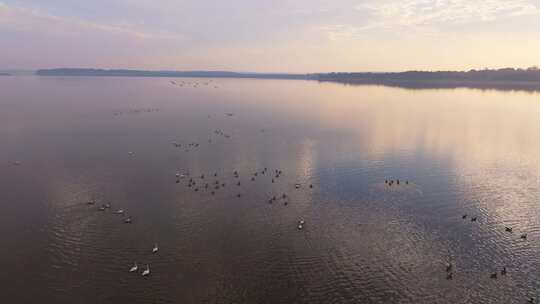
[233,82,540,172]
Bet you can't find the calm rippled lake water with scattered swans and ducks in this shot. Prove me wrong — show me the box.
[0,77,540,303]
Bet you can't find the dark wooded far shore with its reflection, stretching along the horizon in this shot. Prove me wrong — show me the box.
[35,68,540,91]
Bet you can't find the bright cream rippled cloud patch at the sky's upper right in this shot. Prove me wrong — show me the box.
[317,0,540,41]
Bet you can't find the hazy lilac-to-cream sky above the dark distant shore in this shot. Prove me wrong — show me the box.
[0,0,540,72]
